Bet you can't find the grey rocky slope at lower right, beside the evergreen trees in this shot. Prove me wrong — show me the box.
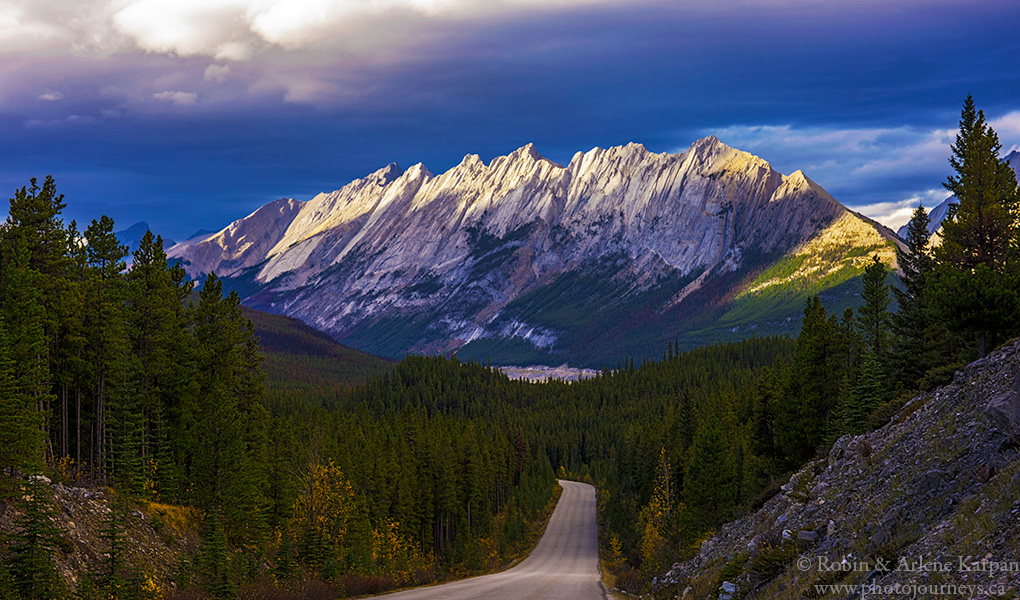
[656,340,1020,599]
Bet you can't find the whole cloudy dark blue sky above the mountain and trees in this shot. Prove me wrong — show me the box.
[0,0,1020,239]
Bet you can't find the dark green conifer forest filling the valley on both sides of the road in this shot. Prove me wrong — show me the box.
[0,98,1020,598]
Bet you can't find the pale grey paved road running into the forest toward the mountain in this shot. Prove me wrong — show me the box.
[381,482,603,600]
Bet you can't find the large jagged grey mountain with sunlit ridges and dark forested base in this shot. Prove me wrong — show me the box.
[168,137,896,367]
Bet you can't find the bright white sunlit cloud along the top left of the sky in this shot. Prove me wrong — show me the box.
[0,0,622,61]
